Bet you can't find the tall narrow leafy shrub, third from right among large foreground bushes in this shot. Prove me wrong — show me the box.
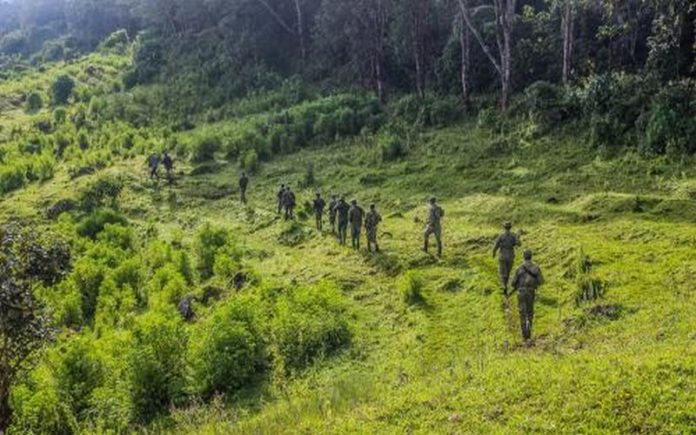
[129,307,188,422]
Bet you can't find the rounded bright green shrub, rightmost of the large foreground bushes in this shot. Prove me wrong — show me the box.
[271,283,352,370]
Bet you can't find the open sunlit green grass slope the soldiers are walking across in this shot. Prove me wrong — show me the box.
[0,56,696,434]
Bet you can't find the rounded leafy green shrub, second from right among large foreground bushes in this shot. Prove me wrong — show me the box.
[187,297,264,397]
